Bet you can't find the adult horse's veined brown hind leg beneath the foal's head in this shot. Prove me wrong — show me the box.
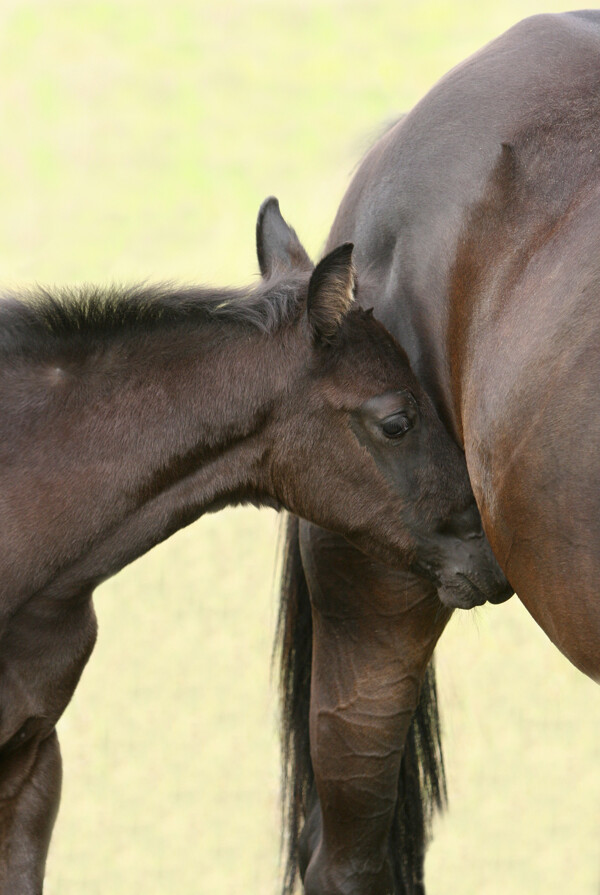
[300,523,450,895]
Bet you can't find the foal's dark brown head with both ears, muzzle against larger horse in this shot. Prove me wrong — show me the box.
[257,199,506,607]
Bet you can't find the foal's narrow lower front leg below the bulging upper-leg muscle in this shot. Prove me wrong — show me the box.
[0,731,62,895]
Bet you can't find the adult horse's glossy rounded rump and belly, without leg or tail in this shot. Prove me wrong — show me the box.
[330,13,600,678]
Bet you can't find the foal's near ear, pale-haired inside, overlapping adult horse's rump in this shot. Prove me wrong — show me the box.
[307,242,355,342]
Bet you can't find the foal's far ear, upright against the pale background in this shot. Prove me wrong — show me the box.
[256,196,313,279]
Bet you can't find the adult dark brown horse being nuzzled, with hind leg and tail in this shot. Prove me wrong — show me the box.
[280,12,600,895]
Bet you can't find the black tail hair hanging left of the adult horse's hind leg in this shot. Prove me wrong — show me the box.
[274,516,314,895]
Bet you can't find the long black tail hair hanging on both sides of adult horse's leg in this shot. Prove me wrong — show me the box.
[275,516,446,895]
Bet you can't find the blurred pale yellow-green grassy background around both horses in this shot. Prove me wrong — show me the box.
[0,0,600,895]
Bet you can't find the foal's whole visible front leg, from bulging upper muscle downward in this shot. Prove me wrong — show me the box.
[0,593,96,895]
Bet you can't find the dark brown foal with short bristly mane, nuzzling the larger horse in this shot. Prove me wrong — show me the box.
[0,199,506,895]
